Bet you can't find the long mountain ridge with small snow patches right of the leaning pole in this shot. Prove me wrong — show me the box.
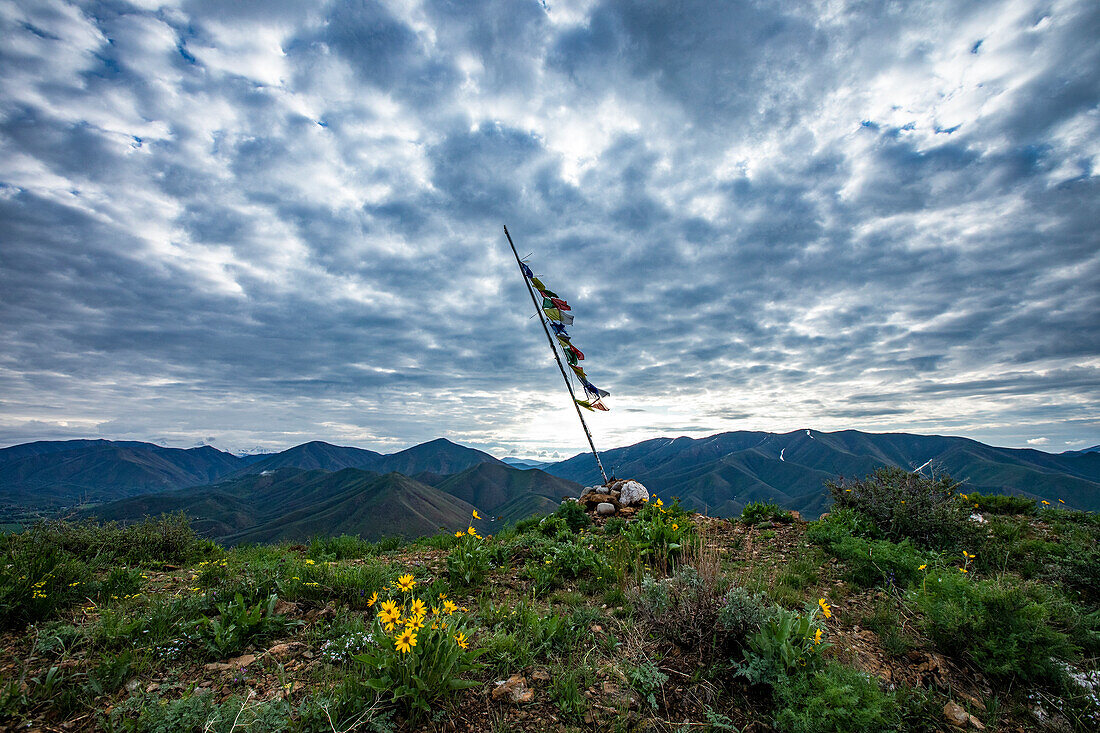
[546,429,1100,516]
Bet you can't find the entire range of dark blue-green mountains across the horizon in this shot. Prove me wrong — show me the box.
[0,429,1100,544]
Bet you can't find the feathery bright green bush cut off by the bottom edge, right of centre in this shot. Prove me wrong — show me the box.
[774,663,894,733]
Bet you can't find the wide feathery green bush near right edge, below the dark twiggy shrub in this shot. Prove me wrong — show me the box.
[915,570,1077,682]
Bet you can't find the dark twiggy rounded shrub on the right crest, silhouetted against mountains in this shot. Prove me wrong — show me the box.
[826,468,976,549]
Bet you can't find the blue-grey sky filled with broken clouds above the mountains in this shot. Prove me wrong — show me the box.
[0,0,1100,457]
